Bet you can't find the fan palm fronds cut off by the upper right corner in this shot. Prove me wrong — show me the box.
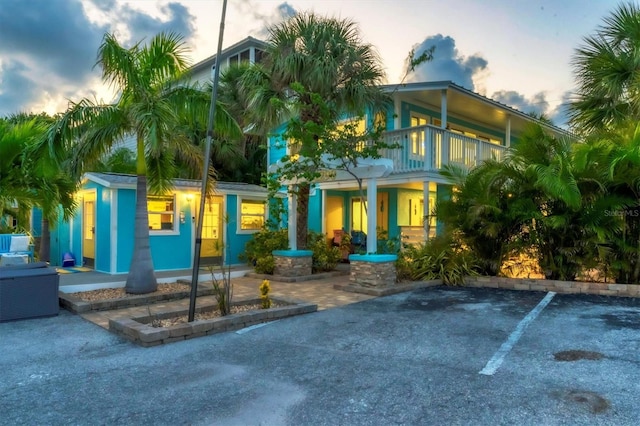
[570,3,640,132]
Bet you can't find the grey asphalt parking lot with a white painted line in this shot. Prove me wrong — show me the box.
[0,287,640,425]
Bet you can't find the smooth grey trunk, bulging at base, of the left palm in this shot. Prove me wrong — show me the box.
[125,175,158,294]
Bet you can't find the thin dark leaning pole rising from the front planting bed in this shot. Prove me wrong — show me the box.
[189,0,227,322]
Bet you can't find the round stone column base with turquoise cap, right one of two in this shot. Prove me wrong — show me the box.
[349,254,398,287]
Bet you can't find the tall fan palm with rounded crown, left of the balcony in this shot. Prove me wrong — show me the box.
[243,13,388,249]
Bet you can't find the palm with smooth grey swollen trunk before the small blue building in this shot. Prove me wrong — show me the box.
[51,33,241,293]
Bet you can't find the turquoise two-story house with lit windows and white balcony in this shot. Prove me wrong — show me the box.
[268,81,567,253]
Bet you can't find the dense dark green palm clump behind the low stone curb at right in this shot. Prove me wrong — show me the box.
[438,126,625,280]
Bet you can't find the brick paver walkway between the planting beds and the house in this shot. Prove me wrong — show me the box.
[76,275,374,328]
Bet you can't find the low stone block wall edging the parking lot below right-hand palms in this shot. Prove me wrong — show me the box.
[465,277,640,297]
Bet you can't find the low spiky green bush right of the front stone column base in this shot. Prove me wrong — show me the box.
[396,235,479,285]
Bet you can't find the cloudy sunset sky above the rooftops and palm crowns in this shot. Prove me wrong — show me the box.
[0,0,619,124]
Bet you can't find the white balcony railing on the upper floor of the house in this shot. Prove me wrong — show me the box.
[380,125,506,174]
